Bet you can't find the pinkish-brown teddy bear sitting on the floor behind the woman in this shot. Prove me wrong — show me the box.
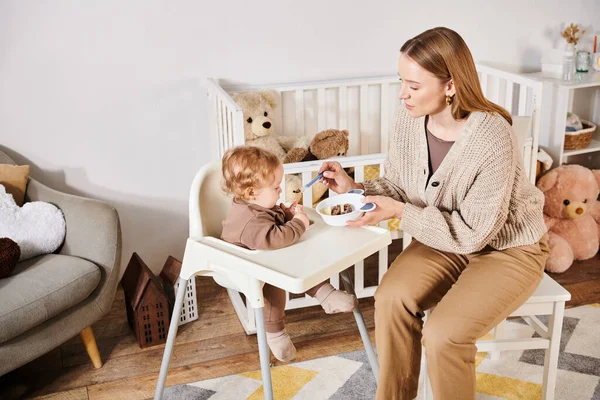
[536,165,600,272]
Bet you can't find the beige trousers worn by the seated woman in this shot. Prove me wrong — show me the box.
[375,236,548,400]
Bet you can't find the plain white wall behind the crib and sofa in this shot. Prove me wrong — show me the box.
[0,0,600,271]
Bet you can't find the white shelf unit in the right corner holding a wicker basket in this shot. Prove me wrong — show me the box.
[526,71,600,168]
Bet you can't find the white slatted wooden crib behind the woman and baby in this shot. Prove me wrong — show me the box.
[207,65,542,334]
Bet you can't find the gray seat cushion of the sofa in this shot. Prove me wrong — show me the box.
[0,254,100,343]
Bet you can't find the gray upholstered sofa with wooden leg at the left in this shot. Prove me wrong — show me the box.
[0,151,121,376]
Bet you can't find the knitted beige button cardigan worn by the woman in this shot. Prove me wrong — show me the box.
[364,107,546,254]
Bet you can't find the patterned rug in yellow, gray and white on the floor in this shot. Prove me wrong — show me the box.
[165,304,600,400]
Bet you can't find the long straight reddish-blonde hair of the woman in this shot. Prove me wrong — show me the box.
[400,27,512,125]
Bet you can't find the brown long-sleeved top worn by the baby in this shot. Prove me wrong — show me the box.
[221,199,306,250]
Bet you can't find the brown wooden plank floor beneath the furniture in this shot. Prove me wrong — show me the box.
[0,241,600,400]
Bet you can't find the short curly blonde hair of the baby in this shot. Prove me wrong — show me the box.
[221,146,281,200]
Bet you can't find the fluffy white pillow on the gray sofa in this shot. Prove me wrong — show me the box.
[0,185,66,261]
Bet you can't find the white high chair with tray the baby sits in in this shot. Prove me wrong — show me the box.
[154,161,391,400]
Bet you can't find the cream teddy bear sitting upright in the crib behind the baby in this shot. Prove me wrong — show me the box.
[233,90,310,202]
